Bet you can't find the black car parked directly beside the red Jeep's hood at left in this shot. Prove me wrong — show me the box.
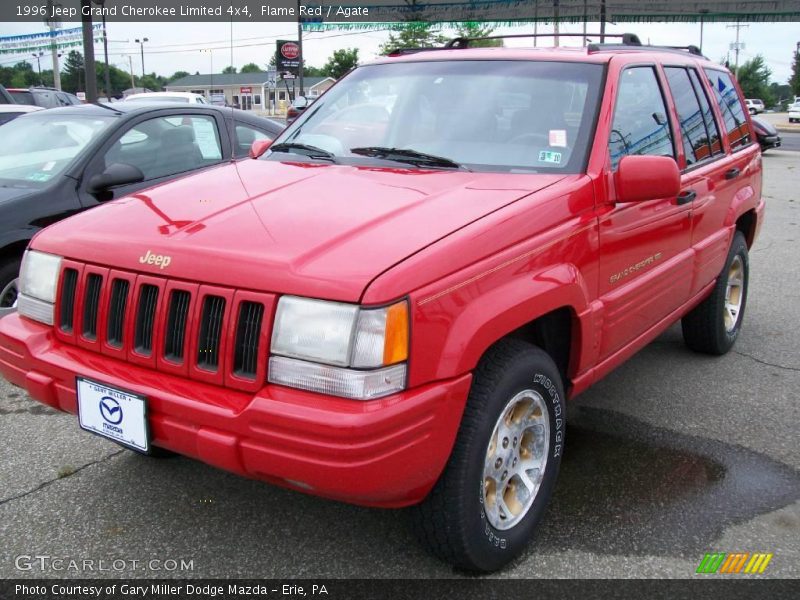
[0,102,283,317]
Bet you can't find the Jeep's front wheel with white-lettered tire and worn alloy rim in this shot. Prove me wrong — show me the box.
[412,340,565,572]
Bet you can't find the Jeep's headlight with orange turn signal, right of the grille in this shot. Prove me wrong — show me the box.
[269,296,408,400]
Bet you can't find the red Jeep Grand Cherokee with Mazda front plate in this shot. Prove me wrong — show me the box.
[0,36,764,571]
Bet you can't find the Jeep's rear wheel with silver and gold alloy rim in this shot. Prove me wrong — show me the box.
[681,231,750,356]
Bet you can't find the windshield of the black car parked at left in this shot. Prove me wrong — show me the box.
[0,111,115,185]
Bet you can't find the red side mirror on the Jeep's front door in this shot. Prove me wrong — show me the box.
[614,155,681,202]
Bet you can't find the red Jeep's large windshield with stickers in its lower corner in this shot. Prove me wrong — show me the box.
[272,60,603,173]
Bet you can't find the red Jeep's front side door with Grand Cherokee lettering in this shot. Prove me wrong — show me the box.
[598,62,692,360]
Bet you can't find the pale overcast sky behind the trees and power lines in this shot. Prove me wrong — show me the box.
[0,23,800,83]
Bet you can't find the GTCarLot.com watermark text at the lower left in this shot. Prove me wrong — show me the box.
[14,554,194,573]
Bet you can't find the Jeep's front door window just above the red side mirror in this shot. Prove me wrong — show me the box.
[608,67,675,169]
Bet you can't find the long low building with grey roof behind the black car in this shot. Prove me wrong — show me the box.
[166,71,335,113]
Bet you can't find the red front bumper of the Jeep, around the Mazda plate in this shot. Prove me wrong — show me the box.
[0,314,471,507]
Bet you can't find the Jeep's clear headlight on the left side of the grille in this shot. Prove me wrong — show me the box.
[17,250,62,325]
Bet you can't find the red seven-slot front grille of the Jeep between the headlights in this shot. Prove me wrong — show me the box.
[55,260,274,391]
